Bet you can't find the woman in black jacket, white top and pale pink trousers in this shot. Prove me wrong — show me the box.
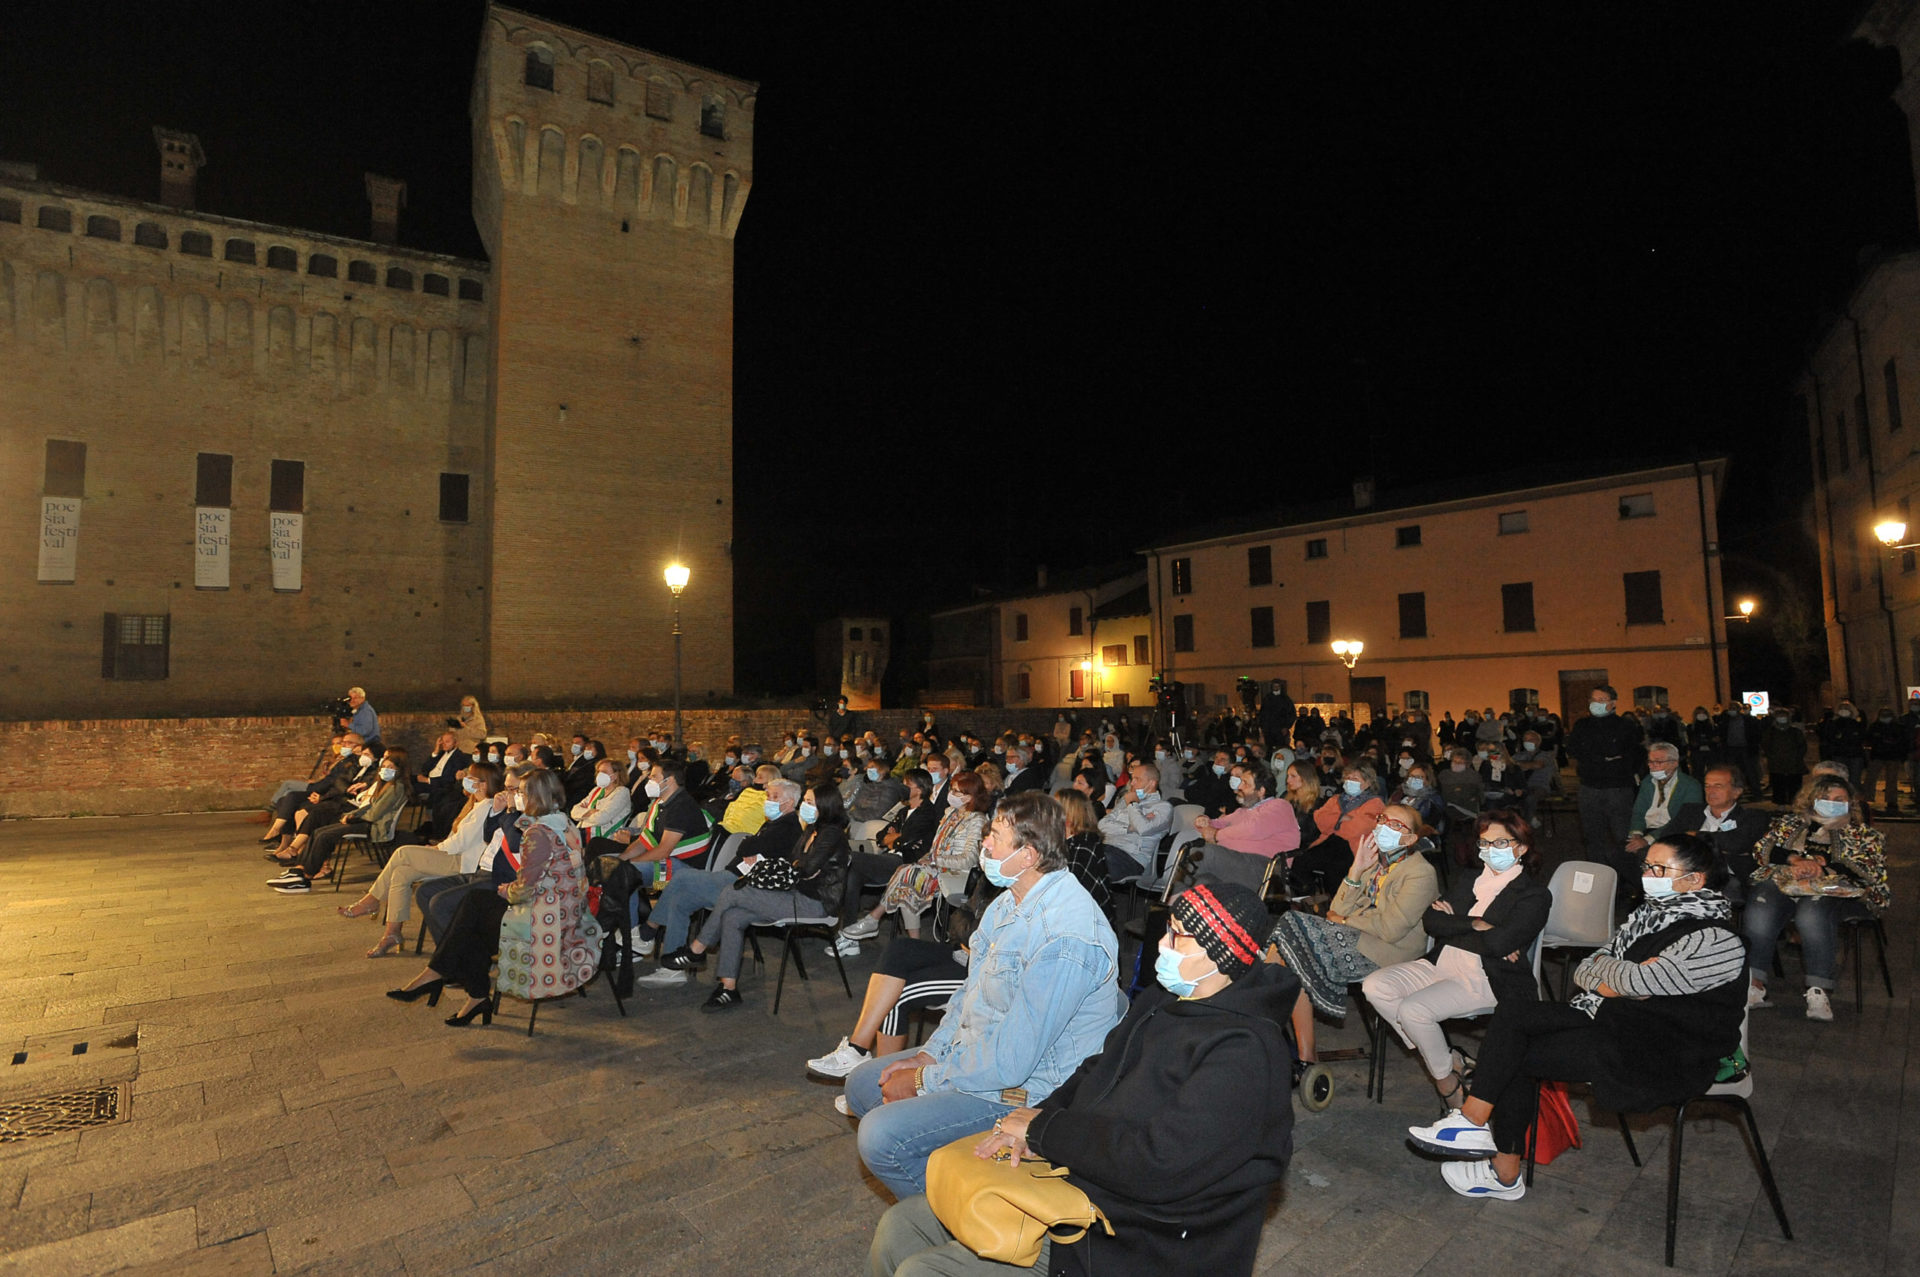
[1359,812,1553,1108]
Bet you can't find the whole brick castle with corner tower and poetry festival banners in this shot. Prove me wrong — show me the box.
[0,6,755,718]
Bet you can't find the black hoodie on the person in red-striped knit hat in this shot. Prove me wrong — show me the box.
[1027,962,1300,1277]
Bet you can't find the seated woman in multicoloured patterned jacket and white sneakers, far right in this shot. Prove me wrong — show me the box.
[1741,776,1893,1020]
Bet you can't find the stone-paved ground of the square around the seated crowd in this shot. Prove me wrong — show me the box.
[0,814,1920,1277]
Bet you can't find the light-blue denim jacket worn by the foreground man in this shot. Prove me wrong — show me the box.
[924,870,1127,1104]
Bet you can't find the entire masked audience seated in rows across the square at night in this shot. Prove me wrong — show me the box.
[247,686,1912,1273]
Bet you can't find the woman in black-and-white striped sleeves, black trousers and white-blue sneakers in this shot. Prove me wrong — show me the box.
[1407,833,1747,1200]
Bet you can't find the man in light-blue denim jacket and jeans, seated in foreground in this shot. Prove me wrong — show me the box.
[847,793,1127,1198]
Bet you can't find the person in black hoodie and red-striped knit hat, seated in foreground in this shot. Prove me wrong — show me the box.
[870,883,1300,1277]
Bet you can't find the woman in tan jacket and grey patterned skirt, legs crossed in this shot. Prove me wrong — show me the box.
[1267,807,1440,1070]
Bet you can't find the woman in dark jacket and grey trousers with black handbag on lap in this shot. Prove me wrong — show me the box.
[660,785,851,1010]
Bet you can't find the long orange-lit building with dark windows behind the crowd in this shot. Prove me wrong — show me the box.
[1148,461,1734,716]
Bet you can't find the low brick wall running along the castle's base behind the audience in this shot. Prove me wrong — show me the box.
[0,709,1082,818]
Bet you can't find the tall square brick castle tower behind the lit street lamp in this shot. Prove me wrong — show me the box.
[470,6,755,703]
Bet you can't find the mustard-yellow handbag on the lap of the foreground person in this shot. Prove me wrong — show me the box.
[927,1131,1114,1267]
